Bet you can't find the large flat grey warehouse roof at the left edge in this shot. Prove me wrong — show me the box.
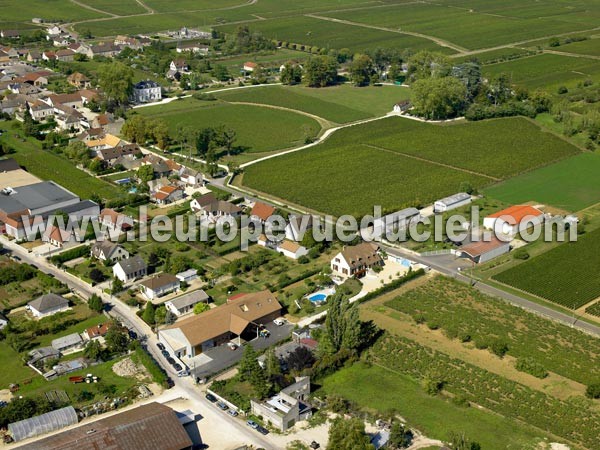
[0,181,79,214]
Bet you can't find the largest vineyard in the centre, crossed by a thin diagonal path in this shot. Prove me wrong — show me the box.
[242,117,578,215]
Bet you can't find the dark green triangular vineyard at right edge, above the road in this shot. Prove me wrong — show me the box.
[492,229,600,309]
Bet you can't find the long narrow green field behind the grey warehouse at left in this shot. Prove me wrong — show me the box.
[0,123,123,199]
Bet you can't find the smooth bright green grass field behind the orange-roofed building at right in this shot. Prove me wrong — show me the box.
[484,153,600,211]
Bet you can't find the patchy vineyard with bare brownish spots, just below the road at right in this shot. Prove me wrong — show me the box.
[385,276,600,385]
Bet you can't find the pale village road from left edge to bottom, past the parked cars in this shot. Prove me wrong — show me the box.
[0,237,280,449]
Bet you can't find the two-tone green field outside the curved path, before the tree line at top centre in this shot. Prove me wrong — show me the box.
[215,84,410,123]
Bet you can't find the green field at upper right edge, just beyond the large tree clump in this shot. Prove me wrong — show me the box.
[483,53,600,91]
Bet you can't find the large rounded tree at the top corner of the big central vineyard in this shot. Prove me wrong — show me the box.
[412,77,467,120]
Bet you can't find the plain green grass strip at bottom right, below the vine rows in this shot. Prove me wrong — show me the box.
[322,363,546,450]
